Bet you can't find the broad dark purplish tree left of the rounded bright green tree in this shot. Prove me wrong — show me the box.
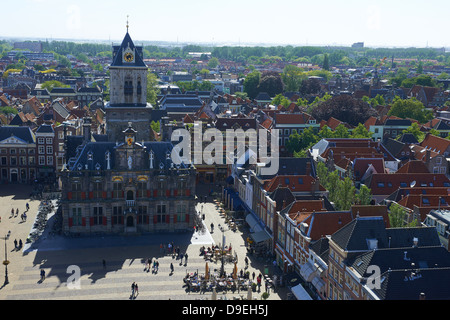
[311,94,377,126]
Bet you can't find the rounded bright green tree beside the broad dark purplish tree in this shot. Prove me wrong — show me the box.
[388,96,433,123]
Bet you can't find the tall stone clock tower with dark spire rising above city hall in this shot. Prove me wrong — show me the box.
[105,26,153,142]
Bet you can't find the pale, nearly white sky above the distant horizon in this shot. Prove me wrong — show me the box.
[0,0,450,48]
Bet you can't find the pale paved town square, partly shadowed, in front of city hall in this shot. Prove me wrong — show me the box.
[0,185,286,300]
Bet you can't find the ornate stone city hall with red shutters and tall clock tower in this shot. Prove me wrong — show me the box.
[60,32,196,234]
